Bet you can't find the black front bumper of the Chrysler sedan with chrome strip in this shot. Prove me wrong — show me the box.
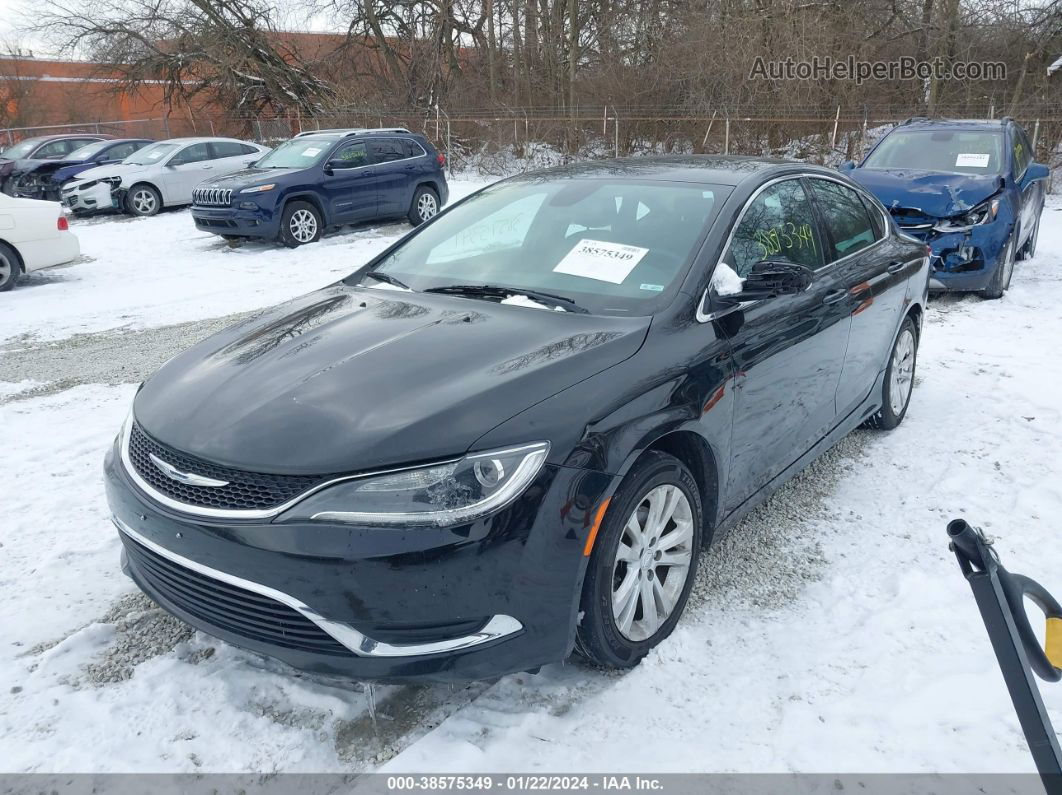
[105,446,612,681]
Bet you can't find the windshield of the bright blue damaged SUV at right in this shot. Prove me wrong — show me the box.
[863,129,1003,174]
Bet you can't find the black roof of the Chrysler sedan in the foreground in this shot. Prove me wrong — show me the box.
[513,155,838,187]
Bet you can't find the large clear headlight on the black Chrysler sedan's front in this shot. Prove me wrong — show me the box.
[286,442,549,526]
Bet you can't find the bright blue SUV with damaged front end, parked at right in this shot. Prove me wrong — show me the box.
[841,117,1050,298]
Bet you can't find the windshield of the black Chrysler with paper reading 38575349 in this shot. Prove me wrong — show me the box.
[350,177,730,315]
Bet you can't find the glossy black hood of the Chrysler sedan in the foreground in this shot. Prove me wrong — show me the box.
[134,284,650,474]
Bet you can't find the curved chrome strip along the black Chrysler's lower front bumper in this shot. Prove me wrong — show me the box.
[112,516,524,657]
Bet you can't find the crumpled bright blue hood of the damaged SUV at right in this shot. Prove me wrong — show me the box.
[849,169,1001,218]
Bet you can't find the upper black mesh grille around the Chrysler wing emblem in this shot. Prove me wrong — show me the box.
[129,422,333,511]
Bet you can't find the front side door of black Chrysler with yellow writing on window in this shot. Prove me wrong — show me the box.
[720,176,851,511]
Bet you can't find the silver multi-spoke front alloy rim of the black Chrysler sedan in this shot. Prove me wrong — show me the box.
[612,485,693,641]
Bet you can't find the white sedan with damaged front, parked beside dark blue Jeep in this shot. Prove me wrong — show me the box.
[63,138,270,215]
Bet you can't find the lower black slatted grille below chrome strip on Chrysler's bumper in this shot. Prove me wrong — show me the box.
[121,533,354,657]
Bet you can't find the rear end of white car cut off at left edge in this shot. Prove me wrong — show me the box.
[0,193,81,293]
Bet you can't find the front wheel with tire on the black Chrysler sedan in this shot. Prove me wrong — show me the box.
[576,452,703,669]
